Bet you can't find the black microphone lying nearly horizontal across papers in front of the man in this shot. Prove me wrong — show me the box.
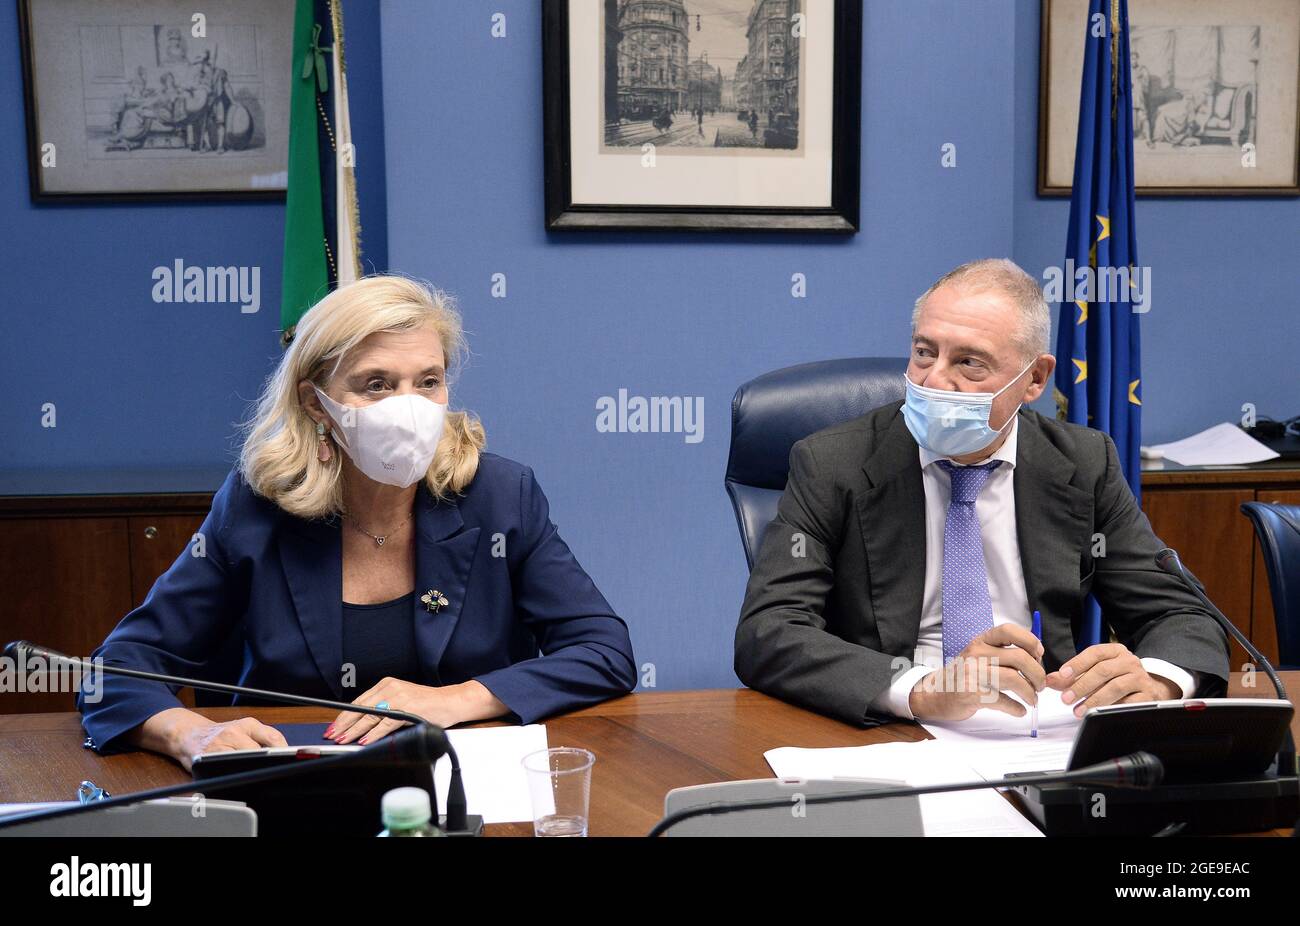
[646,752,1165,836]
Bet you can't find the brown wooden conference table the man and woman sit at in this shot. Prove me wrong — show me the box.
[0,671,1300,836]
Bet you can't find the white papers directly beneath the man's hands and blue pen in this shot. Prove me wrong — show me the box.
[920,688,1082,779]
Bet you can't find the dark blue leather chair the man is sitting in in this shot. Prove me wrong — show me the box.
[725,356,907,568]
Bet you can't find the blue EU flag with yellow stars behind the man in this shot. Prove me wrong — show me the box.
[1056,0,1147,645]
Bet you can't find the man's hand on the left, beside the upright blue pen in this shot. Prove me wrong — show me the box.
[907,624,1047,721]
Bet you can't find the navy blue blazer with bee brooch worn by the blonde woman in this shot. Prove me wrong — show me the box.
[77,453,637,752]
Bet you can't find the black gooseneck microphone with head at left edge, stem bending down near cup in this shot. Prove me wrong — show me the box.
[4,640,468,832]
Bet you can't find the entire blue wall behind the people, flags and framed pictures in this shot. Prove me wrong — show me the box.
[0,0,1300,688]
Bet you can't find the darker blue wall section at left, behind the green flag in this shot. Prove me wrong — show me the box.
[0,0,387,470]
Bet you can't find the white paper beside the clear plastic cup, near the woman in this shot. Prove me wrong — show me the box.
[433,723,547,823]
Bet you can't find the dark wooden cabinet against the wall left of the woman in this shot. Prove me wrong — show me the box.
[0,480,220,714]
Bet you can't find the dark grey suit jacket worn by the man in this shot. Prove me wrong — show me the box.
[736,402,1229,726]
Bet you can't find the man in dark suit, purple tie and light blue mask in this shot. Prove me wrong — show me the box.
[736,260,1229,726]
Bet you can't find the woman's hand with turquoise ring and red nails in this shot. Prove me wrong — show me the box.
[325,679,510,745]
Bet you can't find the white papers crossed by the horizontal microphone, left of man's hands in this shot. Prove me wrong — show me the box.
[763,740,1043,836]
